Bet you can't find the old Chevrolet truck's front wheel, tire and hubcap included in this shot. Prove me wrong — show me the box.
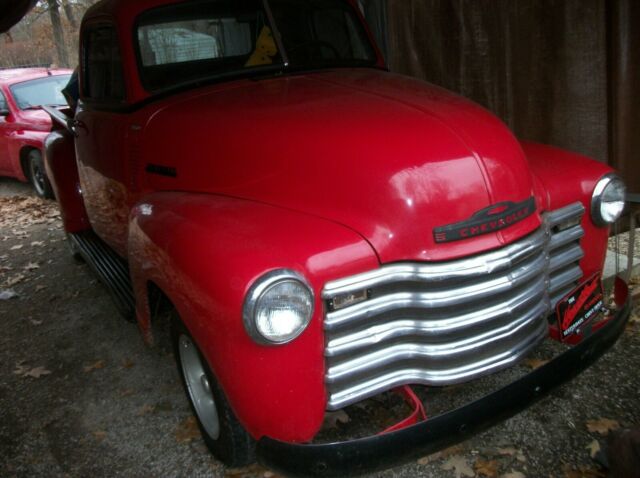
[171,316,255,467]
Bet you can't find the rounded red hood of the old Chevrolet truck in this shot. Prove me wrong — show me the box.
[141,69,540,263]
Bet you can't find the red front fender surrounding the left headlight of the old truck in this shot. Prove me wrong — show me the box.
[128,192,378,442]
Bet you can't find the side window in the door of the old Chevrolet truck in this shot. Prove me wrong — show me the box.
[82,25,125,102]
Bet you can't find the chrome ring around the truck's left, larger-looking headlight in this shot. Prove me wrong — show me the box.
[242,269,315,345]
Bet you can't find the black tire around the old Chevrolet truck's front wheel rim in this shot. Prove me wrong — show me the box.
[171,313,256,467]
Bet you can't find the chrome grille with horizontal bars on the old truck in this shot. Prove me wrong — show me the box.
[322,203,584,410]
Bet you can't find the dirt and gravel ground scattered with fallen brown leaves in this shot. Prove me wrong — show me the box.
[0,179,640,478]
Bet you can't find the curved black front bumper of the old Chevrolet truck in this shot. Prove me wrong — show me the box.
[257,294,631,477]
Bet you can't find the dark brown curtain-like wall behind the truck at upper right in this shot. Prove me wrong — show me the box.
[380,0,640,191]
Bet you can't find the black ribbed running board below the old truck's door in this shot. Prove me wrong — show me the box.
[69,232,136,322]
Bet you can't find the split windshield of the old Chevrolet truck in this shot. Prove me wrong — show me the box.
[136,0,377,92]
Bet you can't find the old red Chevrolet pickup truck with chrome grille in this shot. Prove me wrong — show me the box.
[47,0,629,476]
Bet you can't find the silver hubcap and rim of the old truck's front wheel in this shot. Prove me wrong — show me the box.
[178,335,220,440]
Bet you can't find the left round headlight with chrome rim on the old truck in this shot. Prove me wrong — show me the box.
[243,269,313,344]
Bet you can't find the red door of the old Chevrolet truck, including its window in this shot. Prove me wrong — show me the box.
[74,22,130,256]
